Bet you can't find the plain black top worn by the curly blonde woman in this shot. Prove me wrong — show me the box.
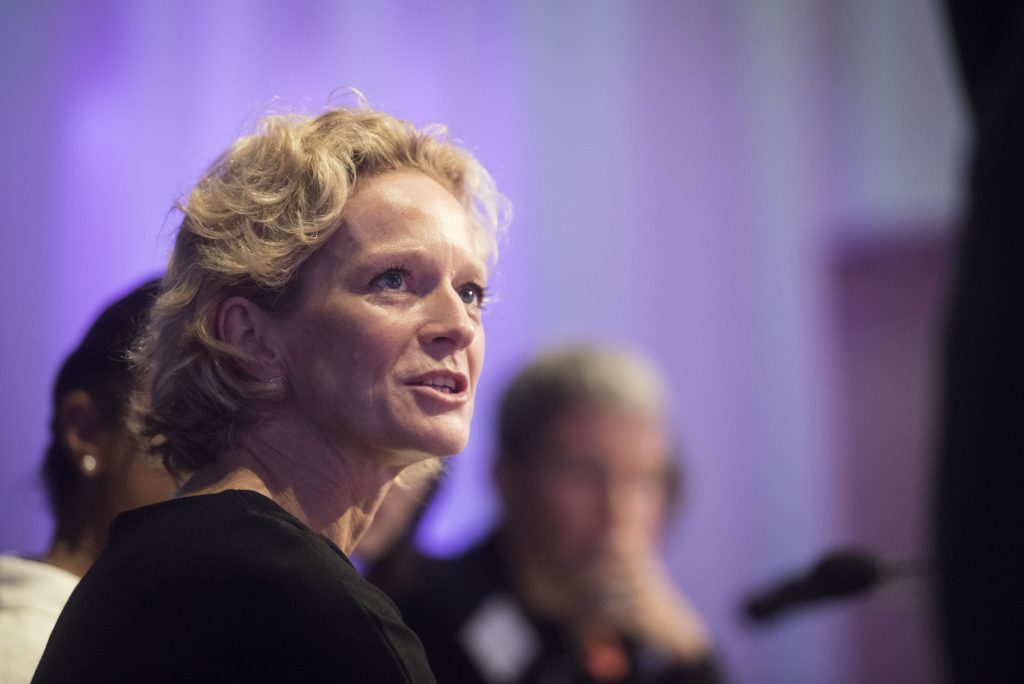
[33,490,434,684]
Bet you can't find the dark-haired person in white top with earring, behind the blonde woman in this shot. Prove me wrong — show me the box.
[0,282,174,684]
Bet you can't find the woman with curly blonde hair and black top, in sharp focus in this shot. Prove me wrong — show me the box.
[35,102,506,682]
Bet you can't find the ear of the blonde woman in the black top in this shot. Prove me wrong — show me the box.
[216,297,284,381]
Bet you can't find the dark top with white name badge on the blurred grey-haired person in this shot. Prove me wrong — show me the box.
[380,536,722,684]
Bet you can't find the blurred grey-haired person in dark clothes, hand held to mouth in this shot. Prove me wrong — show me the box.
[391,347,721,683]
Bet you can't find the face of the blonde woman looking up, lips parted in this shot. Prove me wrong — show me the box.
[281,170,487,465]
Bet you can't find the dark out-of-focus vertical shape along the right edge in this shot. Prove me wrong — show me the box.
[936,0,1024,682]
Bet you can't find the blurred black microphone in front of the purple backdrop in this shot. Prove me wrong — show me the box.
[743,549,906,623]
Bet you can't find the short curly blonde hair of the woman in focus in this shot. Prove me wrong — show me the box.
[132,106,510,474]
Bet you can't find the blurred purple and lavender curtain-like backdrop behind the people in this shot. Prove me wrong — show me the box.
[0,0,967,683]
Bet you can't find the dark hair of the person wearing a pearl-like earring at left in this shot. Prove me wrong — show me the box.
[41,279,160,535]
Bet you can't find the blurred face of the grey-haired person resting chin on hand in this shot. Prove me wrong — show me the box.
[503,408,671,574]
